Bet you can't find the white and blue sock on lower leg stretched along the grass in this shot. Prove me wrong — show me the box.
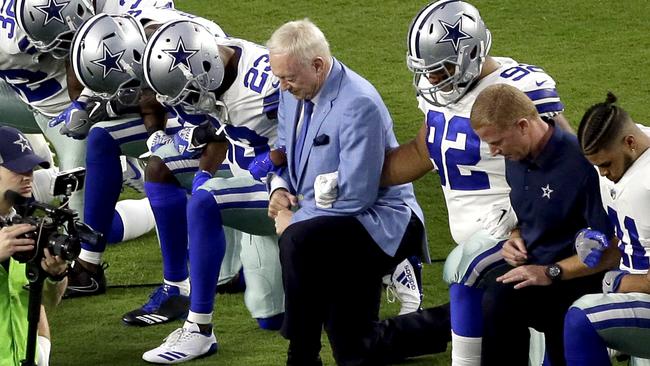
[107,198,156,244]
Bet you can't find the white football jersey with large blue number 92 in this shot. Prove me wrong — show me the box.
[418,57,564,244]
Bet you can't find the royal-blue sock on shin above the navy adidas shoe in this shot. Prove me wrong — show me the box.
[144,182,188,281]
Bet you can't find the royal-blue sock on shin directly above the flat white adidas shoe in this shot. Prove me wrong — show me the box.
[186,190,226,316]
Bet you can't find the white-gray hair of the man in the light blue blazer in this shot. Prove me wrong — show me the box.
[266,18,331,65]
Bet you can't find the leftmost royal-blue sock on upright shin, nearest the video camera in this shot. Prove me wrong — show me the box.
[81,128,122,253]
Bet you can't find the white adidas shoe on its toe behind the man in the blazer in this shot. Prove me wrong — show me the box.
[384,257,422,315]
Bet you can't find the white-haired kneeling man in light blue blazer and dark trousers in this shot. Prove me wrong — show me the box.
[267,19,427,366]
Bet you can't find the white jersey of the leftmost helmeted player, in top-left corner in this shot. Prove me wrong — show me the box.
[0,1,70,117]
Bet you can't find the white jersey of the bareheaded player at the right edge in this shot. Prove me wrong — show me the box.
[600,150,650,273]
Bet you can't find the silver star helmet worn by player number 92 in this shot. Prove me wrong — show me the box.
[406,0,492,106]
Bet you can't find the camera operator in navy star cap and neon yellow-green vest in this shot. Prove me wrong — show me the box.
[0,127,67,366]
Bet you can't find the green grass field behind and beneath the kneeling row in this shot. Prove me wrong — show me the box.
[51,0,650,366]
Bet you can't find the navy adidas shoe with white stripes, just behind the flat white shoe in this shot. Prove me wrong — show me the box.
[122,284,190,327]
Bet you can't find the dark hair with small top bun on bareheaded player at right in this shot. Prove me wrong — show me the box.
[578,92,629,155]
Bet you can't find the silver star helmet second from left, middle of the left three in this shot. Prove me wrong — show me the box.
[71,14,147,105]
